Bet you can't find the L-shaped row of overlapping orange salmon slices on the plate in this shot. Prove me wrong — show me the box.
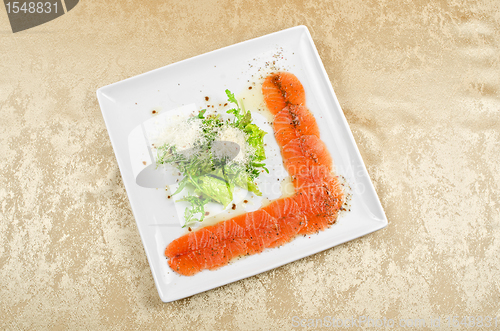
[165,72,343,276]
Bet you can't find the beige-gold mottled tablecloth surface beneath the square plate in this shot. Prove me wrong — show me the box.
[0,0,500,330]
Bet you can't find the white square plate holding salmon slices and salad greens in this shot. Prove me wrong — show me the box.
[97,26,387,302]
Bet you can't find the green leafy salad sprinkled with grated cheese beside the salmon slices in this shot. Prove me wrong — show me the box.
[156,90,269,226]
